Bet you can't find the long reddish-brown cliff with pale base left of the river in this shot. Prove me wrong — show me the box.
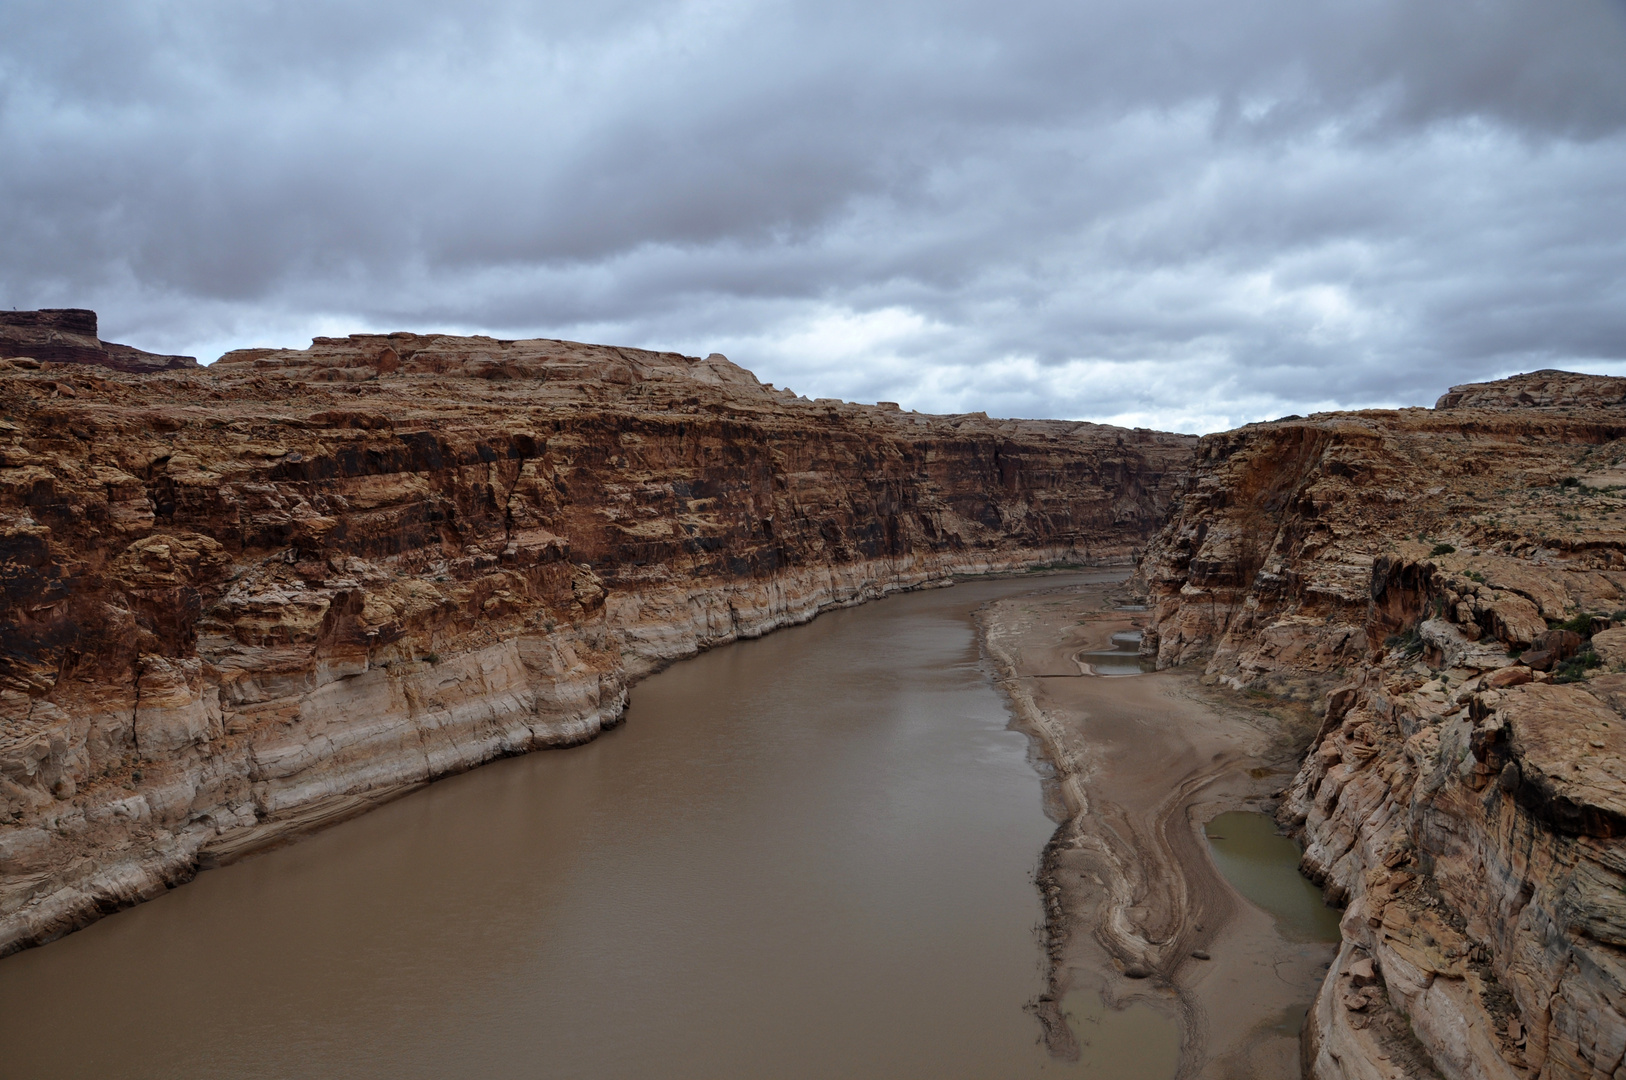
[0,318,1195,953]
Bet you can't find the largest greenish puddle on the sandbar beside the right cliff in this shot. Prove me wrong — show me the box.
[1205,810,1341,942]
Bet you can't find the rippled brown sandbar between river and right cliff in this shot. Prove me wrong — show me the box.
[977,584,1335,1080]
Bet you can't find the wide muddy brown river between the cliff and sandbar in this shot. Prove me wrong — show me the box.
[0,576,1131,1080]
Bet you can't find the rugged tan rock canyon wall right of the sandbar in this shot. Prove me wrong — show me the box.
[1138,371,1626,1080]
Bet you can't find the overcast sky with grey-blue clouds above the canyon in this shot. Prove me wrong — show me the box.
[0,0,1626,431]
